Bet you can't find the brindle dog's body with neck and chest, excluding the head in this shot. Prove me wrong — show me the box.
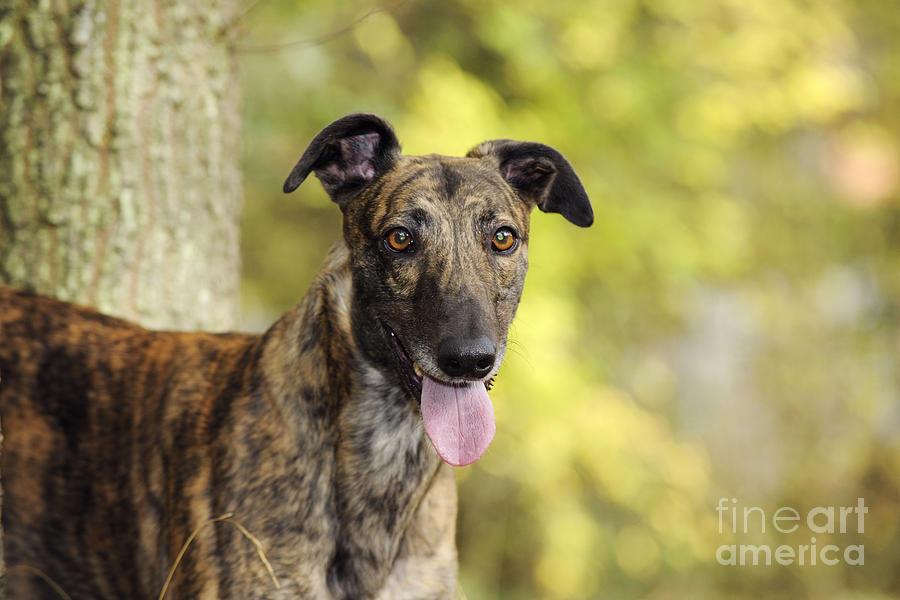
[0,248,455,600]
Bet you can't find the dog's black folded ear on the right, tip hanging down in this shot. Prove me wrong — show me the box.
[466,140,594,227]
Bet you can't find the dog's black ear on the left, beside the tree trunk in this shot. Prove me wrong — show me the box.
[284,113,400,210]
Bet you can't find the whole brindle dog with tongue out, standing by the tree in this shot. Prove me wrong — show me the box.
[0,113,593,600]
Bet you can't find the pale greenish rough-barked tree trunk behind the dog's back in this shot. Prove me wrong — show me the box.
[0,0,241,598]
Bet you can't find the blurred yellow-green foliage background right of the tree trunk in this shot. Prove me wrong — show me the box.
[234,0,900,600]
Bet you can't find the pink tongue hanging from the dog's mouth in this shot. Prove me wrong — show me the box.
[422,375,497,467]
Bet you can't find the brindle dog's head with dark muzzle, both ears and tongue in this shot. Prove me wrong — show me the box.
[284,114,594,465]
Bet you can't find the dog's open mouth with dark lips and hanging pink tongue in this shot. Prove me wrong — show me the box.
[381,322,496,467]
